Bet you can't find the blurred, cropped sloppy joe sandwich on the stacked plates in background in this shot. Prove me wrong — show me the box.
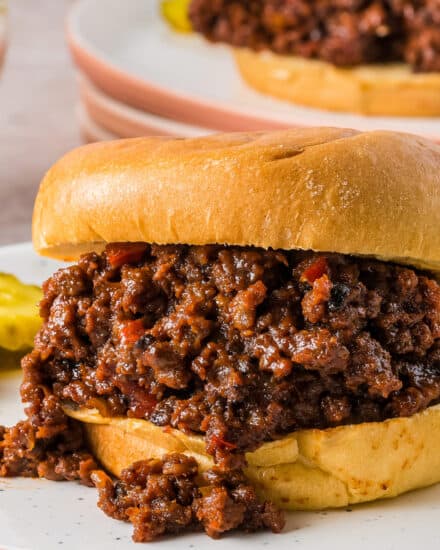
[188,0,440,116]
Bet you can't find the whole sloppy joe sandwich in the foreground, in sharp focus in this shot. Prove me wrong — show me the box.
[3,128,440,540]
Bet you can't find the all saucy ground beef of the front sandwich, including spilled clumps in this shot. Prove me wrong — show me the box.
[0,243,440,540]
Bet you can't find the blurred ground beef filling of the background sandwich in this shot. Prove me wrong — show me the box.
[190,0,440,71]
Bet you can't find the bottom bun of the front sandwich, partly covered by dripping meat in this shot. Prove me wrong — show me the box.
[65,405,440,510]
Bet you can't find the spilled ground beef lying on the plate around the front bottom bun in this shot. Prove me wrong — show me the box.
[0,420,284,542]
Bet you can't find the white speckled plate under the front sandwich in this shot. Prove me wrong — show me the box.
[0,244,440,550]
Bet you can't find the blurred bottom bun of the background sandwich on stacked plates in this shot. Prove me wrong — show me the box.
[234,49,440,116]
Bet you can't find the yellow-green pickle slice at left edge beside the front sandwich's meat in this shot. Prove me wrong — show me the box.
[0,273,42,351]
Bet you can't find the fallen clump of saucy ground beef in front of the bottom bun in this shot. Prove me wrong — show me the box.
[92,454,284,542]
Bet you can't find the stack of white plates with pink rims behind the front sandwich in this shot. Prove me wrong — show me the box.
[67,0,440,141]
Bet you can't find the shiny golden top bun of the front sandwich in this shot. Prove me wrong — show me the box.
[33,128,440,271]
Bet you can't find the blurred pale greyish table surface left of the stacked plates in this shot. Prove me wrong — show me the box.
[0,0,81,245]
